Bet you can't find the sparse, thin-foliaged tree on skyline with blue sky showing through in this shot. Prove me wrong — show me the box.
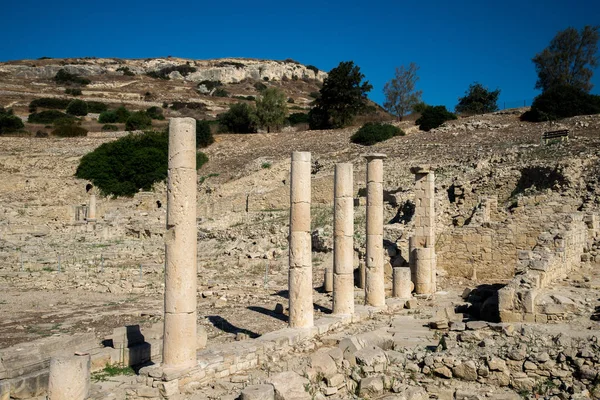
[383,62,423,121]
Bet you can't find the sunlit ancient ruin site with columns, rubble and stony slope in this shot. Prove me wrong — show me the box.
[0,106,600,400]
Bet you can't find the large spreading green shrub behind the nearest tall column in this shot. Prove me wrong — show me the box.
[75,132,208,196]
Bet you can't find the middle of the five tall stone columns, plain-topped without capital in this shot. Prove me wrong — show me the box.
[333,163,354,314]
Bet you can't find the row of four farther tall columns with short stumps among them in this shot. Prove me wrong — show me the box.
[288,152,436,328]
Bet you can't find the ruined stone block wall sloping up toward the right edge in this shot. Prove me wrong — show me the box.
[498,213,597,323]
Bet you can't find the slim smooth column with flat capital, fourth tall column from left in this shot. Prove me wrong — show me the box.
[365,154,386,307]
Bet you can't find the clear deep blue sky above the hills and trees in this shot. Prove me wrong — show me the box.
[0,0,600,108]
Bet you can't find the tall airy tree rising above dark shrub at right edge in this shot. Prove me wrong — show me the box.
[532,25,600,92]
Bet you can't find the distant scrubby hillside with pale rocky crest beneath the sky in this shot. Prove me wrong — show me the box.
[0,57,327,133]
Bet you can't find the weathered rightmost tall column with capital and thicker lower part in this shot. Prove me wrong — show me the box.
[409,166,437,294]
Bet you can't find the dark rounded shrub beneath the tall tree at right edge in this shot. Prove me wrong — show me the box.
[521,85,600,122]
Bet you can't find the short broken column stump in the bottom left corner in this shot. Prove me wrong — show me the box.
[48,354,91,400]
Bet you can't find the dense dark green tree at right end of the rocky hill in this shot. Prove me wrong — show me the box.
[309,61,373,129]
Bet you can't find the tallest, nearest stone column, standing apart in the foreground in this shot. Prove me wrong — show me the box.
[163,118,198,368]
